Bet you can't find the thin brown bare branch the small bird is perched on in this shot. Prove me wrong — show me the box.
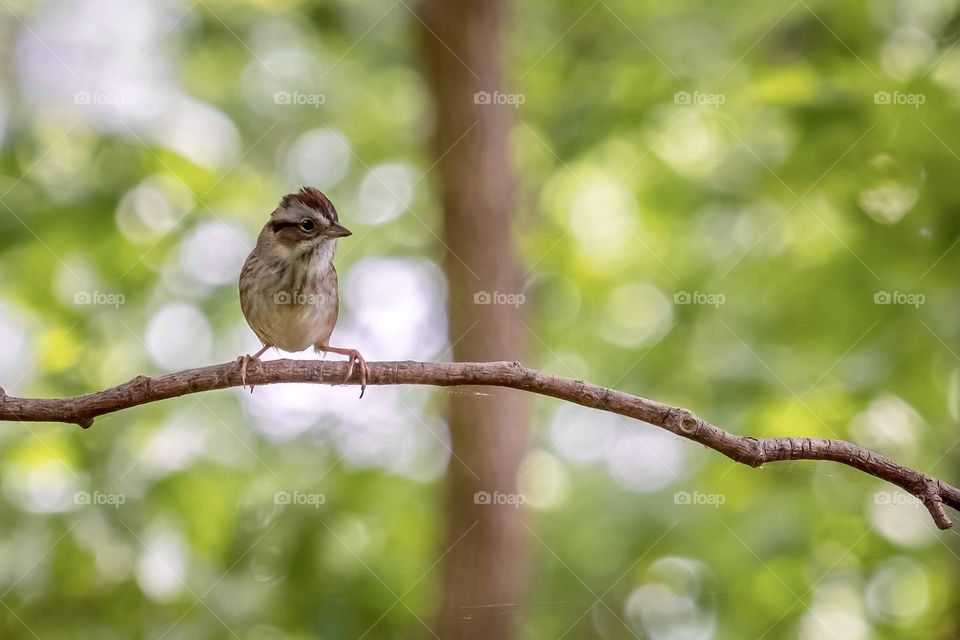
[0,360,960,529]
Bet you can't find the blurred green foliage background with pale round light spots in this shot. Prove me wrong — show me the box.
[0,0,960,640]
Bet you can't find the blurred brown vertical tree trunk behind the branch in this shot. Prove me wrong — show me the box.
[418,0,529,640]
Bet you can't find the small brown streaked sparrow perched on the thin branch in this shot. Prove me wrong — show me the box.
[237,187,367,398]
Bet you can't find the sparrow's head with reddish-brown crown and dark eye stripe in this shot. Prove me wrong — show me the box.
[263,187,351,253]
